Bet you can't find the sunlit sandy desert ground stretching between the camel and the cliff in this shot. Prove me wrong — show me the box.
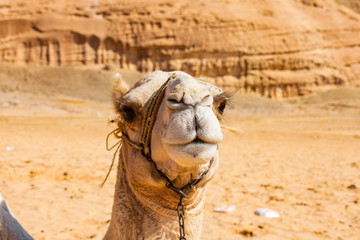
[0,64,360,240]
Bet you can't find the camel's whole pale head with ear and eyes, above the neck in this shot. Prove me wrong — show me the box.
[114,71,228,186]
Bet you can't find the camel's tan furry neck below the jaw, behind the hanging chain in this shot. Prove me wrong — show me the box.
[104,147,205,239]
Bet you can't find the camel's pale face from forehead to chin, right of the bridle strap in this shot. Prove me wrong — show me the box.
[153,75,223,167]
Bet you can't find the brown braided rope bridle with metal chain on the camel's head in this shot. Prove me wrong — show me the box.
[109,73,213,240]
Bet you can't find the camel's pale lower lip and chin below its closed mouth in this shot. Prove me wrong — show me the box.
[165,141,218,167]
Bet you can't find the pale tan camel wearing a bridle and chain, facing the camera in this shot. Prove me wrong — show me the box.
[0,71,229,240]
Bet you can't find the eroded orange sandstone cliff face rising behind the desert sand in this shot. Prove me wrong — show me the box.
[0,0,360,97]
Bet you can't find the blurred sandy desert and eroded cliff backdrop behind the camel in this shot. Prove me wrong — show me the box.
[0,0,360,240]
